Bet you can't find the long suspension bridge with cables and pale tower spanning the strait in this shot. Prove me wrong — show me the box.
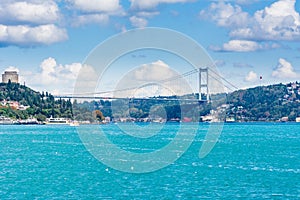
[54,67,238,102]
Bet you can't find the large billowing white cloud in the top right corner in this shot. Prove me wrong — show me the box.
[230,0,300,41]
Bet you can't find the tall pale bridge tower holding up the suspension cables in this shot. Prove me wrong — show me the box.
[199,67,209,101]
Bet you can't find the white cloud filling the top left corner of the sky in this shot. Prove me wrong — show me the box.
[0,1,60,25]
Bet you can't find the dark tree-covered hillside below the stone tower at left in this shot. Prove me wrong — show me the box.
[0,82,72,121]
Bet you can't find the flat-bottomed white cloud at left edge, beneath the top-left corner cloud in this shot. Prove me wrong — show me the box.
[0,24,68,46]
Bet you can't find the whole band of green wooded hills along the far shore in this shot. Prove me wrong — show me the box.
[0,82,300,122]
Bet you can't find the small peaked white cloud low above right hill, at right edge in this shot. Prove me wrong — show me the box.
[272,58,300,78]
